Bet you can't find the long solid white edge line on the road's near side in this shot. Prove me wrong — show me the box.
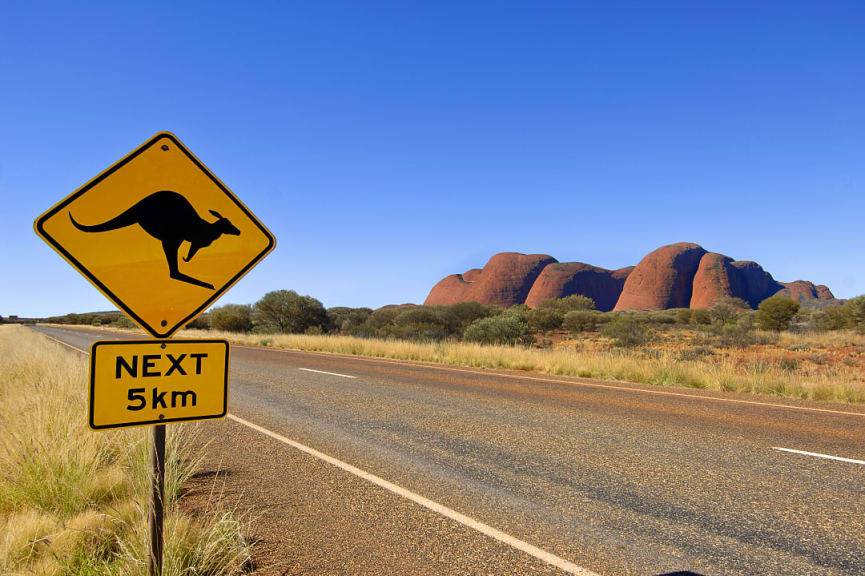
[228,414,598,576]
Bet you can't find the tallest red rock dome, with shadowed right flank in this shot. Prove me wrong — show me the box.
[614,242,706,310]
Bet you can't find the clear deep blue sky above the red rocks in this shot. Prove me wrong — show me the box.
[0,2,865,316]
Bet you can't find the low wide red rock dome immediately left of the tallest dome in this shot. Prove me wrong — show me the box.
[526,262,633,312]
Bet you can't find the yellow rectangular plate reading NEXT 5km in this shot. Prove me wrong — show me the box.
[90,340,228,430]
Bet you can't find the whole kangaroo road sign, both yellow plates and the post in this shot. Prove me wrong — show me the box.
[34,132,276,576]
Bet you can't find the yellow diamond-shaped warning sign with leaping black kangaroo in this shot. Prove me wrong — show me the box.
[35,132,275,338]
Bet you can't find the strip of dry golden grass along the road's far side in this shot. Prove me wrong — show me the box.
[50,328,865,403]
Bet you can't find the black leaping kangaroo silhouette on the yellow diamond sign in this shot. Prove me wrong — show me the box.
[69,190,240,290]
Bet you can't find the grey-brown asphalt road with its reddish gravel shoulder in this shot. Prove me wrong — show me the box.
[37,327,865,575]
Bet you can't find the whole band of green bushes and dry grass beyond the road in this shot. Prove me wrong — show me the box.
[30,290,865,403]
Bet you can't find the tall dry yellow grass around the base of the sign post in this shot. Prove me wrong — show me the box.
[0,326,249,576]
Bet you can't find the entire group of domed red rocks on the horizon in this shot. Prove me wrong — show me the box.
[424,242,840,311]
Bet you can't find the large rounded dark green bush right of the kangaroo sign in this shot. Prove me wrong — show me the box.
[252,290,327,334]
